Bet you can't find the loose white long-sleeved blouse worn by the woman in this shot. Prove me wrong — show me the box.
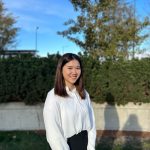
[43,87,96,150]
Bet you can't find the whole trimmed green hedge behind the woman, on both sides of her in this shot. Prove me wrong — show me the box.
[0,54,150,104]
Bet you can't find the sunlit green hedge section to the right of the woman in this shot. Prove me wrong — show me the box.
[84,58,150,105]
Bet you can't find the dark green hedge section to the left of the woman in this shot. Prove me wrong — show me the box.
[0,55,59,104]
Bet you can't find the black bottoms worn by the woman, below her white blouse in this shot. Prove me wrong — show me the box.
[67,131,88,150]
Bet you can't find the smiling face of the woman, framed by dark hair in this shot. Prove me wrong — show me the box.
[62,59,81,89]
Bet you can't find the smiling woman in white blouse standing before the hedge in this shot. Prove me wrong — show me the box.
[43,53,96,150]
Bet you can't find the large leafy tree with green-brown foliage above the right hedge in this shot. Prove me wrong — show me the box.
[58,0,150,58]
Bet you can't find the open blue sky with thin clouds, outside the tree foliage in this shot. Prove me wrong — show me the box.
[3,0,150,56]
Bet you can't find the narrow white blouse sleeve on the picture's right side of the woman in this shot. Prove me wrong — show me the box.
[87,92,96,150]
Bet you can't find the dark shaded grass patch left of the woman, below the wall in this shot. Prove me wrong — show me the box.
[0,131,50,150]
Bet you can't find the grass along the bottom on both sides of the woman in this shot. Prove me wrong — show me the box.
[0,131,150,150]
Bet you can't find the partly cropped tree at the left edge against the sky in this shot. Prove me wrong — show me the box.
[0,0,18,51]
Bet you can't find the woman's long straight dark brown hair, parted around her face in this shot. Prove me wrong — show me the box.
[54,53,85,99]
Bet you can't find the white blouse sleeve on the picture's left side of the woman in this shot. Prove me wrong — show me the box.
[43,94,70,150]
